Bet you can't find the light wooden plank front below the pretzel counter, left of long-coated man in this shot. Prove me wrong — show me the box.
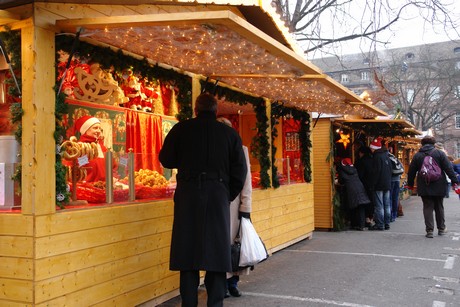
[30,200,179,306]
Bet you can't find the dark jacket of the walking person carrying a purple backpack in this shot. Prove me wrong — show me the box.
[407,144,458,196]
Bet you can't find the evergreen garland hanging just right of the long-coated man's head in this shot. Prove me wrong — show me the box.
[200,80,276,189]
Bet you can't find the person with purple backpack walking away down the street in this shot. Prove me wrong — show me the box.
[407,136,458,238]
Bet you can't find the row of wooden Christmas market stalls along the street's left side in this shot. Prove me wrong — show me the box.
[0,0,411,306]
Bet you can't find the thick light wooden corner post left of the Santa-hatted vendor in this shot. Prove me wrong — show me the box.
[21,25,56,215]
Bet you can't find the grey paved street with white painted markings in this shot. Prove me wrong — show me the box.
[142,192,460,307]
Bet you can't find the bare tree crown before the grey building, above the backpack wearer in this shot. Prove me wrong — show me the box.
[380,45,460,135]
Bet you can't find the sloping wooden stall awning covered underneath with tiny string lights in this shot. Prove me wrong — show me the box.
[56,11,386,118]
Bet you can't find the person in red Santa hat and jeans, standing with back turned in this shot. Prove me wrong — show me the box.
[369,137,391,230]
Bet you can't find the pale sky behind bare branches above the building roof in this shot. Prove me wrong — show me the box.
[272,0,460,53]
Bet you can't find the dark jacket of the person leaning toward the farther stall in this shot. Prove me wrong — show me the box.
[339,164,371,209]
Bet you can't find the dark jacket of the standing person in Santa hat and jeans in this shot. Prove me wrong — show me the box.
[371,148,392,191]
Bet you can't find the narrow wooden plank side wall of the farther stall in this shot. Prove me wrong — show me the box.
[312,118,334,229]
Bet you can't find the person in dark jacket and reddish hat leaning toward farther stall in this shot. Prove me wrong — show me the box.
[338,158,370,230]
